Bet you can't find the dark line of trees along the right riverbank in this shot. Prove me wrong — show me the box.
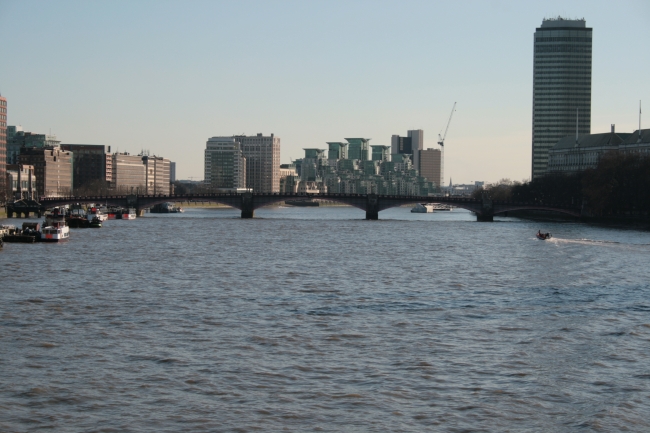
[473,152,650,217]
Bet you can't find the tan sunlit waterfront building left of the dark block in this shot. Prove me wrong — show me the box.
[18,146,73,197]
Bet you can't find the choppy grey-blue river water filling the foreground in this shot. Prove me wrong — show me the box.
[0,208,650,432]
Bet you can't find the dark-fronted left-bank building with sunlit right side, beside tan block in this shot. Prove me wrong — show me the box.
[61,144,113,194]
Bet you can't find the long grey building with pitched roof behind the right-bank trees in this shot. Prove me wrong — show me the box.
[547,125,650,174]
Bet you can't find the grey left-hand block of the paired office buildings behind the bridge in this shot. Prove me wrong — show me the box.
[203,137,246,189]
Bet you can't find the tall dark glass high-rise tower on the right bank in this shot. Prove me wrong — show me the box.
[531,17,592,178]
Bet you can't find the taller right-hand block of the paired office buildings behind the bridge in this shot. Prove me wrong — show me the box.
[233,134,280,192]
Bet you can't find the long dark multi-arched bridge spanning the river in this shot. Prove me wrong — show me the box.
[31,192,581,221]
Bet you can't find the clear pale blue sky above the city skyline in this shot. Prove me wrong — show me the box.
[0,0,650,182]
